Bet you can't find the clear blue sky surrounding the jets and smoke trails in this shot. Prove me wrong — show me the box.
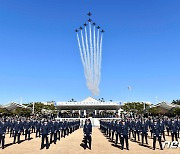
[0,0,180,103]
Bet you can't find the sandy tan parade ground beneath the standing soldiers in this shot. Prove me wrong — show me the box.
[0,127,180,154]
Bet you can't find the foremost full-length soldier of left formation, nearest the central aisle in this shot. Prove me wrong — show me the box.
[41,121,49,149]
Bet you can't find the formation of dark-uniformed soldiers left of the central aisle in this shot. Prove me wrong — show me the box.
[0,118,80,149]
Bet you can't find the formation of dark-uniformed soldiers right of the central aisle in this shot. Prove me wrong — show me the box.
[100,118,180,150]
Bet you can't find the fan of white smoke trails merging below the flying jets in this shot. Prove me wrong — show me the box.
[77,22,103,95]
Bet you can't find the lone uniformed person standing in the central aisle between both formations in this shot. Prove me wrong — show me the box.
[83,119,92,149]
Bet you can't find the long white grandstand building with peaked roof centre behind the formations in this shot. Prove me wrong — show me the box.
[56,97,122,117]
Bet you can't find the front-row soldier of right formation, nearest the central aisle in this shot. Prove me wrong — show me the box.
[121,120,129,150]
